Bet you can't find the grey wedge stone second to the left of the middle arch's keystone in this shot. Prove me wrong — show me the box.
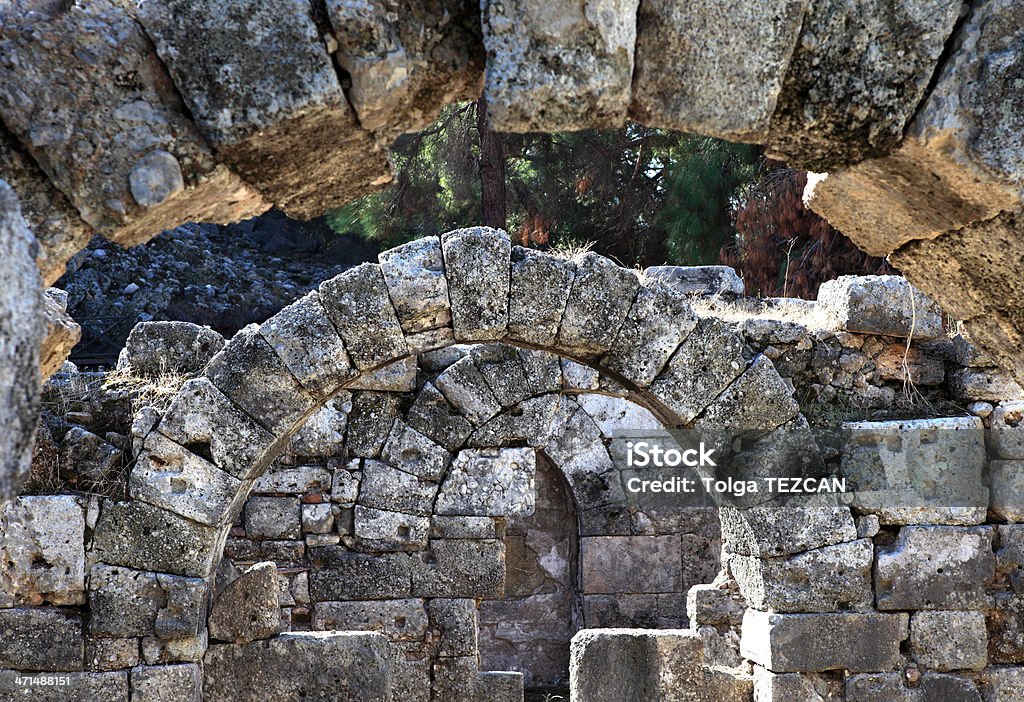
[319,263,409,370]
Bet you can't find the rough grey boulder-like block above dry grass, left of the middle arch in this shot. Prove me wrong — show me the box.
[118,321,224,378]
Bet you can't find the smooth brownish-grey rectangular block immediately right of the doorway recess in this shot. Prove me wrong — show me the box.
[580,535,682,594]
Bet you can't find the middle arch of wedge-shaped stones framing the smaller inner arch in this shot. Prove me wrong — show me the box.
[81,228,831,699]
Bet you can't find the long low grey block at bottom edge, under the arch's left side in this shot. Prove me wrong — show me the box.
[203,631,391,702]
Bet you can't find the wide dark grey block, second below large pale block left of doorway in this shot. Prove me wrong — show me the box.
[413,538,505,598]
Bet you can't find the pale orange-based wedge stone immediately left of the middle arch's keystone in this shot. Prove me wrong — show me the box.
[378,236,452,334]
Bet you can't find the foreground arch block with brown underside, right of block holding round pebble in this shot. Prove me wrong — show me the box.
[139,0,390,221]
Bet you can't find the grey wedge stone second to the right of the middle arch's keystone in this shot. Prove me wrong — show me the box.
[557,252,640,355]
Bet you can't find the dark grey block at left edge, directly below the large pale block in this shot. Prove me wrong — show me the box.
[0,608,85,670]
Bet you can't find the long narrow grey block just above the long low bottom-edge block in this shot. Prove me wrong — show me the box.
[313,599,428,641]
